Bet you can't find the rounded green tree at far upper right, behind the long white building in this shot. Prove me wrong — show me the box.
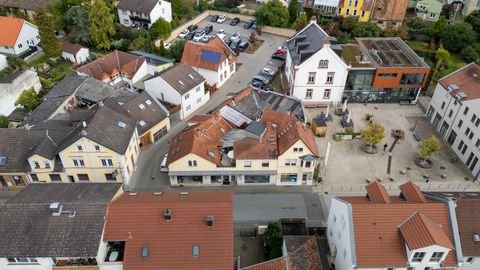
[440,23,476,53]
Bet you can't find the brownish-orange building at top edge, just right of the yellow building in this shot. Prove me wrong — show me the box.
[371,0,408,29]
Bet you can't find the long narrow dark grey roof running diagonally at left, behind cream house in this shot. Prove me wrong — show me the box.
[26,74,87,126]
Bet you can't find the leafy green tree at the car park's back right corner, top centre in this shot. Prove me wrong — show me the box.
[255,0,289,27]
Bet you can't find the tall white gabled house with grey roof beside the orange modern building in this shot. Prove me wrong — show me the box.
[285,17,348,106]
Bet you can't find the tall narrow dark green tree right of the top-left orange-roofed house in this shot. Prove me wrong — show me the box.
[33,7,60,57]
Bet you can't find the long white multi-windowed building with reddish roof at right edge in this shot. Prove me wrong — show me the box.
[427,63,480,180]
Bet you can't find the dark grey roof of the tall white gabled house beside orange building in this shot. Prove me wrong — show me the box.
[287,23,336,65]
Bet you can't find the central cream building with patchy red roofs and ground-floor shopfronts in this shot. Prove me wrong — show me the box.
[167,88,318,186]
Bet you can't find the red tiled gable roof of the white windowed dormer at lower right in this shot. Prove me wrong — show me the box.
[399,212,455,250]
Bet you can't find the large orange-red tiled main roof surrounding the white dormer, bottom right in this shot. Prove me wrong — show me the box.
[340,181,456,268]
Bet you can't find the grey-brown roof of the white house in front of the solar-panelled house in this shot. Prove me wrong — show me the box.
[155,63,205,95]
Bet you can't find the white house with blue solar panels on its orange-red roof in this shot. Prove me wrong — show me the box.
[181,37,237,88]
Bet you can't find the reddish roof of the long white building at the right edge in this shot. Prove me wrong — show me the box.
[440,63,480,100]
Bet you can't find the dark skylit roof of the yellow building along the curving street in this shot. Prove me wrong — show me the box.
[122,92,168,135]
